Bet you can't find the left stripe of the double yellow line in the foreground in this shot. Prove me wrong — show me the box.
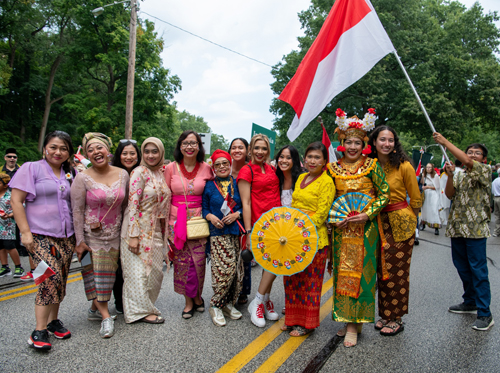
[217,278,333,373]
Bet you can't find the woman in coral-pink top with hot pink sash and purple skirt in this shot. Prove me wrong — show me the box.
[165,131,213,319]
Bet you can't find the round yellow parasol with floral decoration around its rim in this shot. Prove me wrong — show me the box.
[250,207,318,276]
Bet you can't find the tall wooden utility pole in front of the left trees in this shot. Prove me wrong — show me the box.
[125,0,137,139]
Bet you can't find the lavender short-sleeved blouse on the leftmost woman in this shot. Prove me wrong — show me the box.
[9,159,75,238]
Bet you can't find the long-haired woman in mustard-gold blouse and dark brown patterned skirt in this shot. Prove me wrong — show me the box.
[368,126,422,336]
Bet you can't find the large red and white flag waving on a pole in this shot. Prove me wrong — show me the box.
[278,0,394,141]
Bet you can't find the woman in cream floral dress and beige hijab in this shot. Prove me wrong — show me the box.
[121,137,171,324]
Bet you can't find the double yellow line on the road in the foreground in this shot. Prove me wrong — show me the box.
[217,278,333,373]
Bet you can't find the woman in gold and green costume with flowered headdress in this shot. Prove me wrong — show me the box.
[328,109,389,347]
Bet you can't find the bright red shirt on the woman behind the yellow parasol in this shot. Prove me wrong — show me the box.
[237,162,281,225]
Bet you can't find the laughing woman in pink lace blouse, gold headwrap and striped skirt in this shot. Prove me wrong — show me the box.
[71,132,129,338]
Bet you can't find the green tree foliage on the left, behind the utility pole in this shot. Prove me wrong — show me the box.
[0,0,224,162]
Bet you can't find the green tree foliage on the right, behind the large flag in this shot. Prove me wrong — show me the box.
[271,0,500,163]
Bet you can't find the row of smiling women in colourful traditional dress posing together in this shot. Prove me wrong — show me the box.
[10,106,421,349]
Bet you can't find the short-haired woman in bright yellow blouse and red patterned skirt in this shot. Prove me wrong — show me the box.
[282,142,335,337]
